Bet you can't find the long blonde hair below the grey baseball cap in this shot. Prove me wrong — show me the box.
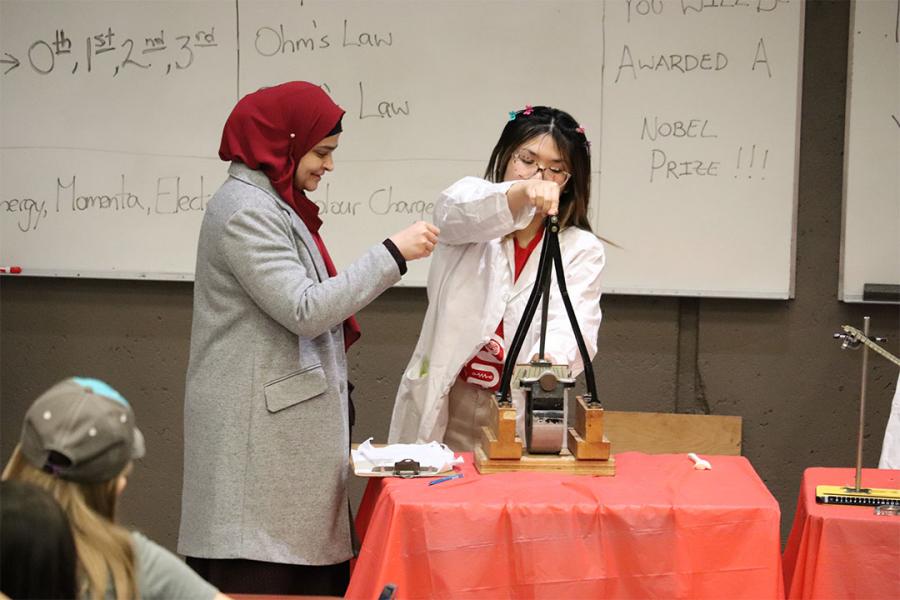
[3,445,138,600]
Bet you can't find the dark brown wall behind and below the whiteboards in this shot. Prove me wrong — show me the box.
[0,1,900,548]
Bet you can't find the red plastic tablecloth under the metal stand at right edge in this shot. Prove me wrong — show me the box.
[784,467,900,599]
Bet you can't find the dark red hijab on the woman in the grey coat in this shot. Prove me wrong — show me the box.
[219,81,360,349]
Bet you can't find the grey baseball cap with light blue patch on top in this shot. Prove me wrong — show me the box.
[21,377,144,483]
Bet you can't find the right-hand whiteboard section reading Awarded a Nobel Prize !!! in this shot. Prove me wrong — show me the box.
[596,0,803,298]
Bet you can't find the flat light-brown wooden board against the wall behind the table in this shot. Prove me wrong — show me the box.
[604,410,741,456]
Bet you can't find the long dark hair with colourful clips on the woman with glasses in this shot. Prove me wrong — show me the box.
[484,106,591,231]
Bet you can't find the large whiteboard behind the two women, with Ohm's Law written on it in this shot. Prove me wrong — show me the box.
[0,0,802,298]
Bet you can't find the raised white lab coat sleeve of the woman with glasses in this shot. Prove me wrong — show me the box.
[434,177,534,244]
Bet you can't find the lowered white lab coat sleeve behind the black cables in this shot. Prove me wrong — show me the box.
[528,234,606,377]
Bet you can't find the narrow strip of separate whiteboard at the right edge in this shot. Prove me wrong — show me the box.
[838,0,900,302]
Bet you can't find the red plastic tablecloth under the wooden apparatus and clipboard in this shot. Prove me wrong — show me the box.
[347,452,784,600]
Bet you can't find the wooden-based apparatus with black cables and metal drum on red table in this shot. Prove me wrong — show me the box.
[476,216,615,475]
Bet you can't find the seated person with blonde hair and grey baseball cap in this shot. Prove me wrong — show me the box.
[3,377,232,600]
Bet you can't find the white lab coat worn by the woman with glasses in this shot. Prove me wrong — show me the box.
[388,177,606,443]
